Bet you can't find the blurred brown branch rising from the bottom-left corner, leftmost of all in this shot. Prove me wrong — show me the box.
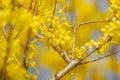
[0,24,14,80]
